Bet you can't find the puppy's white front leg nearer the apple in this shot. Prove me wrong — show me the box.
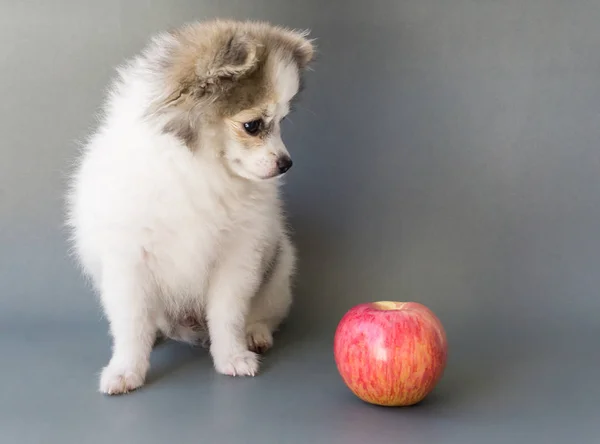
[206,245,260,376]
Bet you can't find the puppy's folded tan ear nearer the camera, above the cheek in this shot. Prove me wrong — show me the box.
[196,31,258,87]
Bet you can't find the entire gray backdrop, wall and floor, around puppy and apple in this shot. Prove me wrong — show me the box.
[0,0,600,444]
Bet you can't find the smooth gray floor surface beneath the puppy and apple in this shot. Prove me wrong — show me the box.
[0,321,600,444]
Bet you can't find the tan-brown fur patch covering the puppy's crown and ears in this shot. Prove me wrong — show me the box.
[150,21,314,149]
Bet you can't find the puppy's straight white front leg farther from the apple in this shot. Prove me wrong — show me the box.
[100,266,157,395]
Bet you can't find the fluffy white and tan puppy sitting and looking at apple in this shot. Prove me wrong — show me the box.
[66,20,313,394]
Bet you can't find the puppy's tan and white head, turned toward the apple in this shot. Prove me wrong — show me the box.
[146,21,314,180]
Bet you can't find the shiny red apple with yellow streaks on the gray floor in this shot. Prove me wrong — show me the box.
[334,301,448,406]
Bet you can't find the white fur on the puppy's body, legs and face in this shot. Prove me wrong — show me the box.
[68,30,298,394]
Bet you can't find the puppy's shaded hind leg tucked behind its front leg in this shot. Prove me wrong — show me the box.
[246,237,296,353]
